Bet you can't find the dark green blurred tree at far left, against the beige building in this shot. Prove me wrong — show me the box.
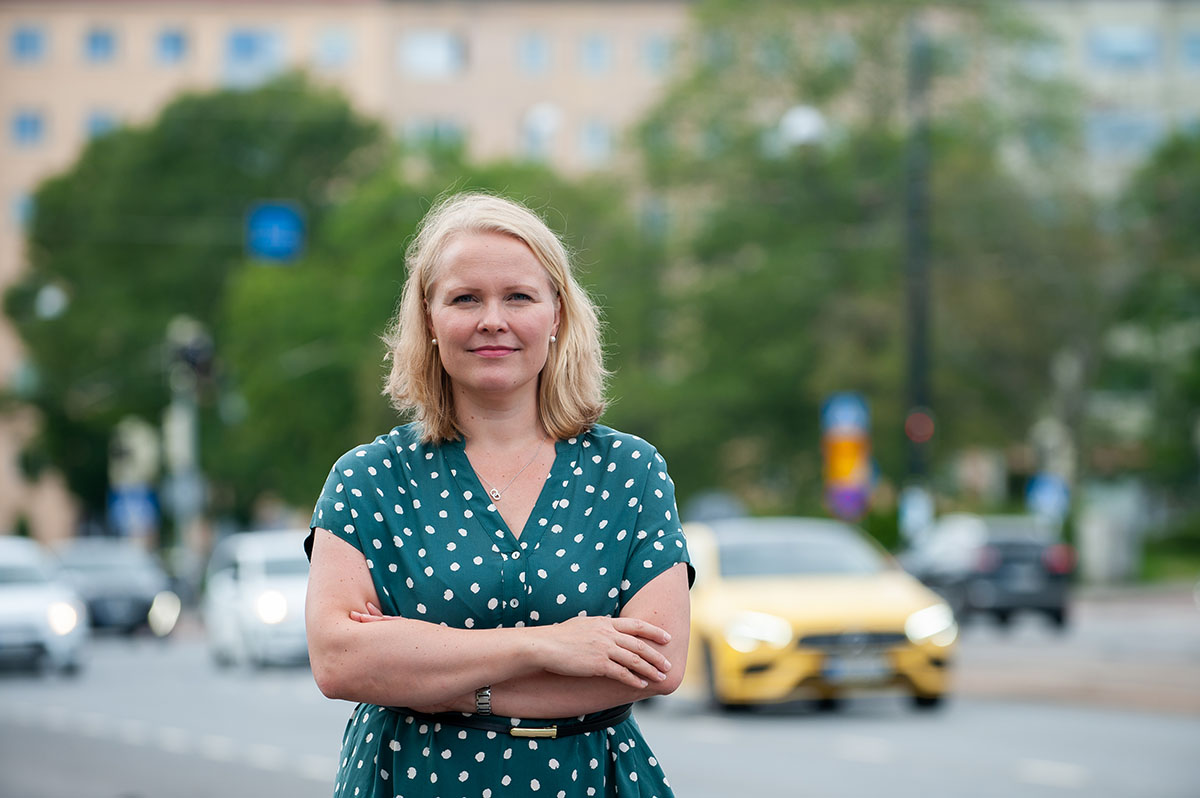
[6,77,386,514]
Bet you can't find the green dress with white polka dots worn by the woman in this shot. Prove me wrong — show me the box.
[312,425,688,798]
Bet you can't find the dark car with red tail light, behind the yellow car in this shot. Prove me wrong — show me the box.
[900,514,1075,629]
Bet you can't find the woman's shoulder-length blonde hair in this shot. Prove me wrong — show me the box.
[383,192,608,443]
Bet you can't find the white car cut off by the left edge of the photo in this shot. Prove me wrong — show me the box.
[0,535,90,674]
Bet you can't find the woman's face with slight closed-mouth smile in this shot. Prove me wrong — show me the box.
[426,233,559,400]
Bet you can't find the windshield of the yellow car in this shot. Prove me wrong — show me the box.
[718,524,888,577]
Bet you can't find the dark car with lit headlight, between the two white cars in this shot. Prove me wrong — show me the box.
[58,536,180,637]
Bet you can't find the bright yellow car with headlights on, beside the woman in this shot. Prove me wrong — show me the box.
[684,517,958,708]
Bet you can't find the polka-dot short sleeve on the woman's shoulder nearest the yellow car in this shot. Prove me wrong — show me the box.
[620,450,695,607]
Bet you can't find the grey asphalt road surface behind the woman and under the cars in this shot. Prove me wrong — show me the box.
[0,583,1200,798]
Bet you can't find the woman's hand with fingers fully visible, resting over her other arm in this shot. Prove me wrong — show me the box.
[529,616,671,688]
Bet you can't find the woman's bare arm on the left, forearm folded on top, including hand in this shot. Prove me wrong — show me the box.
[305,529,686,715]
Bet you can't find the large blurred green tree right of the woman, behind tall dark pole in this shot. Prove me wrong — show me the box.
[638,0,1104,511]
